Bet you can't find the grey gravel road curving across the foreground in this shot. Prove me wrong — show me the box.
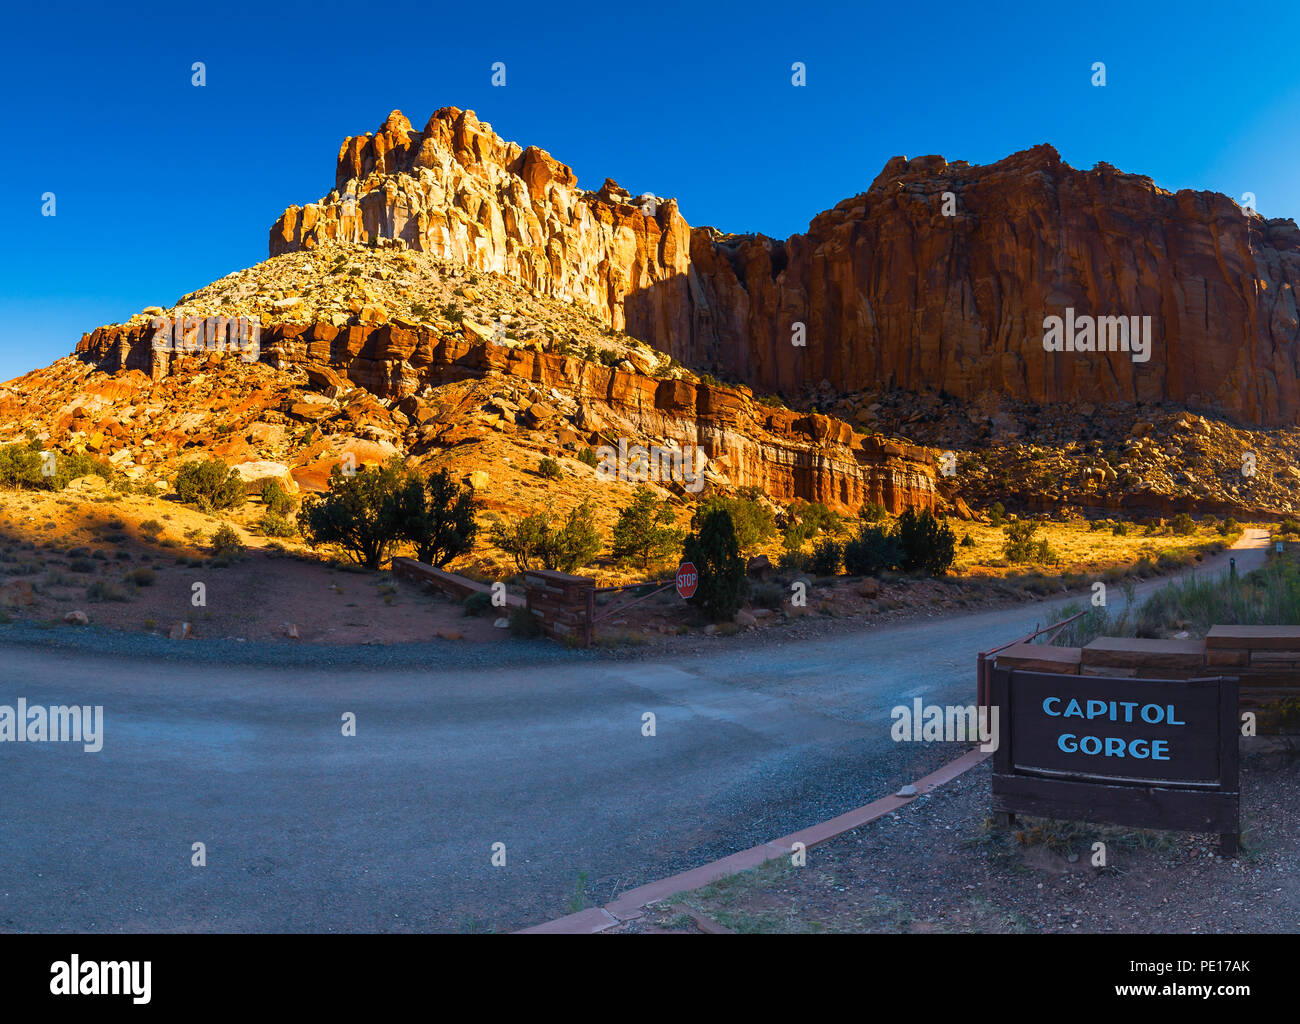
[0,534,1265,932]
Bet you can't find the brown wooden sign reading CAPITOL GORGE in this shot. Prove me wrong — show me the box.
[991,668,1240,854]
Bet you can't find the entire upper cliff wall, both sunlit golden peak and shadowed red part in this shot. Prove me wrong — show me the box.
[270,108,1300,425]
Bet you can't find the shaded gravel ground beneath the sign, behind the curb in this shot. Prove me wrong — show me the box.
[623,745,1300,934]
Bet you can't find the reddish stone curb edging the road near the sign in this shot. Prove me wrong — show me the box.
[515,747,992,936]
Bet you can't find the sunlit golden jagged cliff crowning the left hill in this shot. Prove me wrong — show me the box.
[270,107,690,351]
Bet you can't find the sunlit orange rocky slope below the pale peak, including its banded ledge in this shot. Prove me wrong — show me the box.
[0,243,948,524]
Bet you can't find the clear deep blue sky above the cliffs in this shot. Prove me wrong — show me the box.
[0,0,1300,379]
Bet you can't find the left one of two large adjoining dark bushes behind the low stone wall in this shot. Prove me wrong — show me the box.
[298,459,404,569]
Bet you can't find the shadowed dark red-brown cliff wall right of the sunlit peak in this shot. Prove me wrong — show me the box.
[683,146,1300,425]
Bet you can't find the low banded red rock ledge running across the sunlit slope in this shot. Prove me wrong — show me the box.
[77,322,943,513]
